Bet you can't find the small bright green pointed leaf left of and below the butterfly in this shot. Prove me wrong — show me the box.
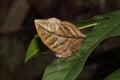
[25,35,46,62]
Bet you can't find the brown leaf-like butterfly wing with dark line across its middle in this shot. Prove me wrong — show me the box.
[35,18,85,58]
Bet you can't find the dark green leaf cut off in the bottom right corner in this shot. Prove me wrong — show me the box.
[104,69,120,80]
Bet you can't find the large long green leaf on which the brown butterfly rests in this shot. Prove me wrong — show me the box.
[43,11,120,80]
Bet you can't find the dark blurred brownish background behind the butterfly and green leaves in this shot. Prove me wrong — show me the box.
[0,0,120,80]
